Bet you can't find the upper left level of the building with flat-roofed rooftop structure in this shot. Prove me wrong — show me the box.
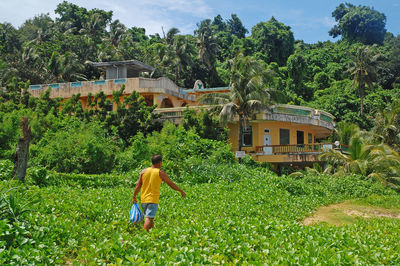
[29,60,196,107]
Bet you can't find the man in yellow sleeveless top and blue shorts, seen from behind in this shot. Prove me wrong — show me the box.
[133,154,186,232]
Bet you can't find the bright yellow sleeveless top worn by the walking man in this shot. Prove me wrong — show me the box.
[140,167,162,204]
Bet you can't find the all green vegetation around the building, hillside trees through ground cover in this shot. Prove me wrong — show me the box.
[0,2,400,265]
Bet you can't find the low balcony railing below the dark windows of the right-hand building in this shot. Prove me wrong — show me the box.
[256,143,348,155]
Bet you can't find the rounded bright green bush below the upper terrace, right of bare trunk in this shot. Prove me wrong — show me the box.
[31,123,119,174]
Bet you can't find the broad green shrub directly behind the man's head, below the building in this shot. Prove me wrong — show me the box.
[116,122,235,177]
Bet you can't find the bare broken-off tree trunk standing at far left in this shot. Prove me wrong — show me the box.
[13,117,31,182]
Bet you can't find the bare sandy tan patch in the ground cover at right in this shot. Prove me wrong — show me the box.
[303,201,400,225]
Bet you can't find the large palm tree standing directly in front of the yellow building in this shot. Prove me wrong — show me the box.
[199,53,273,151]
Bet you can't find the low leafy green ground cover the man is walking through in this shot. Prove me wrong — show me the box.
[0,170,400,265]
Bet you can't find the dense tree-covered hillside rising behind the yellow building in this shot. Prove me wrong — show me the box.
[0,1,400,129]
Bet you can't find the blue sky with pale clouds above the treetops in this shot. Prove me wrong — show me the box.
[0,0,400,43]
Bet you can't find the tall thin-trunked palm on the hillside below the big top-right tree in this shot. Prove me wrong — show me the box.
[348,46,382,115]
